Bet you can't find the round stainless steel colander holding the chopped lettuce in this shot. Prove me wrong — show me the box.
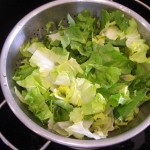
[0,0,150,148]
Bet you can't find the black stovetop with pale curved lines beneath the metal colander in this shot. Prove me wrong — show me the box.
[0,0,150,150]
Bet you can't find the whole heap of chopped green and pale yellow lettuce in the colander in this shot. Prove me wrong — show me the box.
[13,9,150,140]
